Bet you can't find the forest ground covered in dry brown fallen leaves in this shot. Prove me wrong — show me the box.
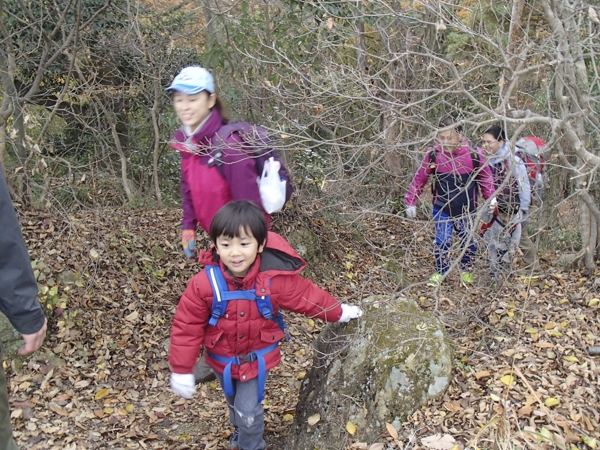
[7,206,600,450]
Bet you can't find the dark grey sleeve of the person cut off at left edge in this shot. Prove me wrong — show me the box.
[0,167,46,345]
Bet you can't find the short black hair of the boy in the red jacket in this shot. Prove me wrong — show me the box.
[209,200,268,244]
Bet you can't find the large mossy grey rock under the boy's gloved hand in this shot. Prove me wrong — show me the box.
[284,296,453,450]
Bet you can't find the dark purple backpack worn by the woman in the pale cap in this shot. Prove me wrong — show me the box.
[208,122,294,207]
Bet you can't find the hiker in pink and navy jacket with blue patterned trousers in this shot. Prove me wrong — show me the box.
[404,117,494,286]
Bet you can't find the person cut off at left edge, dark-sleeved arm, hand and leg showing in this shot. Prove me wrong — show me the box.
[0,167,47,450]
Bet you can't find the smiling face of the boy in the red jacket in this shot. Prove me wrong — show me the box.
[215,228,264,278]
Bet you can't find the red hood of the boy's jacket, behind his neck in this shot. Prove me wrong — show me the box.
[198,231,306,278]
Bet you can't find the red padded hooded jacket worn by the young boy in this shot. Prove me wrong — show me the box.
[169,232,342,380]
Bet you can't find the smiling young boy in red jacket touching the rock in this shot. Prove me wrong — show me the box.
[169,201,362,450]
